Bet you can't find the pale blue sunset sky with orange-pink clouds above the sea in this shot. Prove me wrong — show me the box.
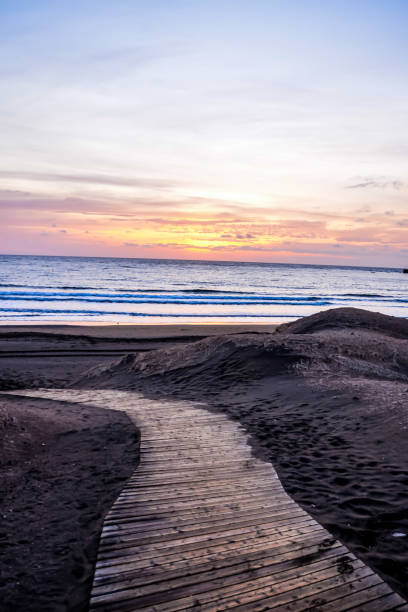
[0,0,408,267]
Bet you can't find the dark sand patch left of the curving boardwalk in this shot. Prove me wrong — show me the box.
[0,395,139,612]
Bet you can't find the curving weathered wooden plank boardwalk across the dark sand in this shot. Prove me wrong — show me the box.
[10,389,408,612]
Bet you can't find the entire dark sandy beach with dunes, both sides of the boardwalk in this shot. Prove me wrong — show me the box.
[0,308,408,610]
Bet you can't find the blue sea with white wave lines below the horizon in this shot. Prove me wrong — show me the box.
[0,255,408,324]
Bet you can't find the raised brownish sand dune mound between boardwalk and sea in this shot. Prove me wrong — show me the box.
[75,308,408,389]
